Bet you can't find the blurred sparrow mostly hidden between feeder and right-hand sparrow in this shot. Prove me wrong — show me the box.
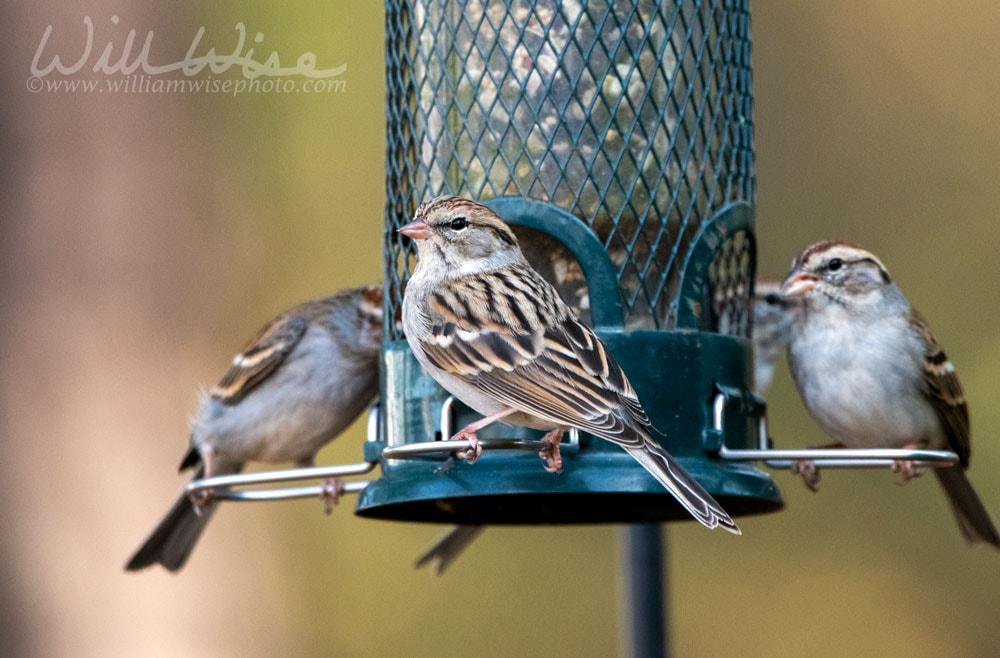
[752,279,799,400]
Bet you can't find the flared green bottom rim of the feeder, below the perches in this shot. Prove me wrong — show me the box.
[355,453,782,524]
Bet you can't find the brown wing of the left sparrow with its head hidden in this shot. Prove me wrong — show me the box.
[210,315,309,405]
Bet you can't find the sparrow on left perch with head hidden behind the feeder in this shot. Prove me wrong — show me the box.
[125,285,382,571]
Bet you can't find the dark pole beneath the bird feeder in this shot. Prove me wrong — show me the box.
[621,523,667,658]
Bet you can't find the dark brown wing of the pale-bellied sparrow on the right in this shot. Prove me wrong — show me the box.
[911,310,971,467]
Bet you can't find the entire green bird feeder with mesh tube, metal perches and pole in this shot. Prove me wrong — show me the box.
[188,0,958,655]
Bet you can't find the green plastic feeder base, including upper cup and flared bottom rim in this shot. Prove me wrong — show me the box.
[355,331,783,524]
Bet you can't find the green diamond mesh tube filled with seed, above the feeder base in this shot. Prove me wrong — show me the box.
[385,0,753,328]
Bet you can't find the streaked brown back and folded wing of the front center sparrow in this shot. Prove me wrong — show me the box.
[421,270,649,447]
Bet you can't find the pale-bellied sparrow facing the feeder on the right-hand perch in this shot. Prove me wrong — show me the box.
[781,242,1000,548]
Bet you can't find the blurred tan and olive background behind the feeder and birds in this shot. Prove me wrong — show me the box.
[0,0,1000,657]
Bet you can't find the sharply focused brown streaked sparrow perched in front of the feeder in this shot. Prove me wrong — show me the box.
[400,196,739,533]
